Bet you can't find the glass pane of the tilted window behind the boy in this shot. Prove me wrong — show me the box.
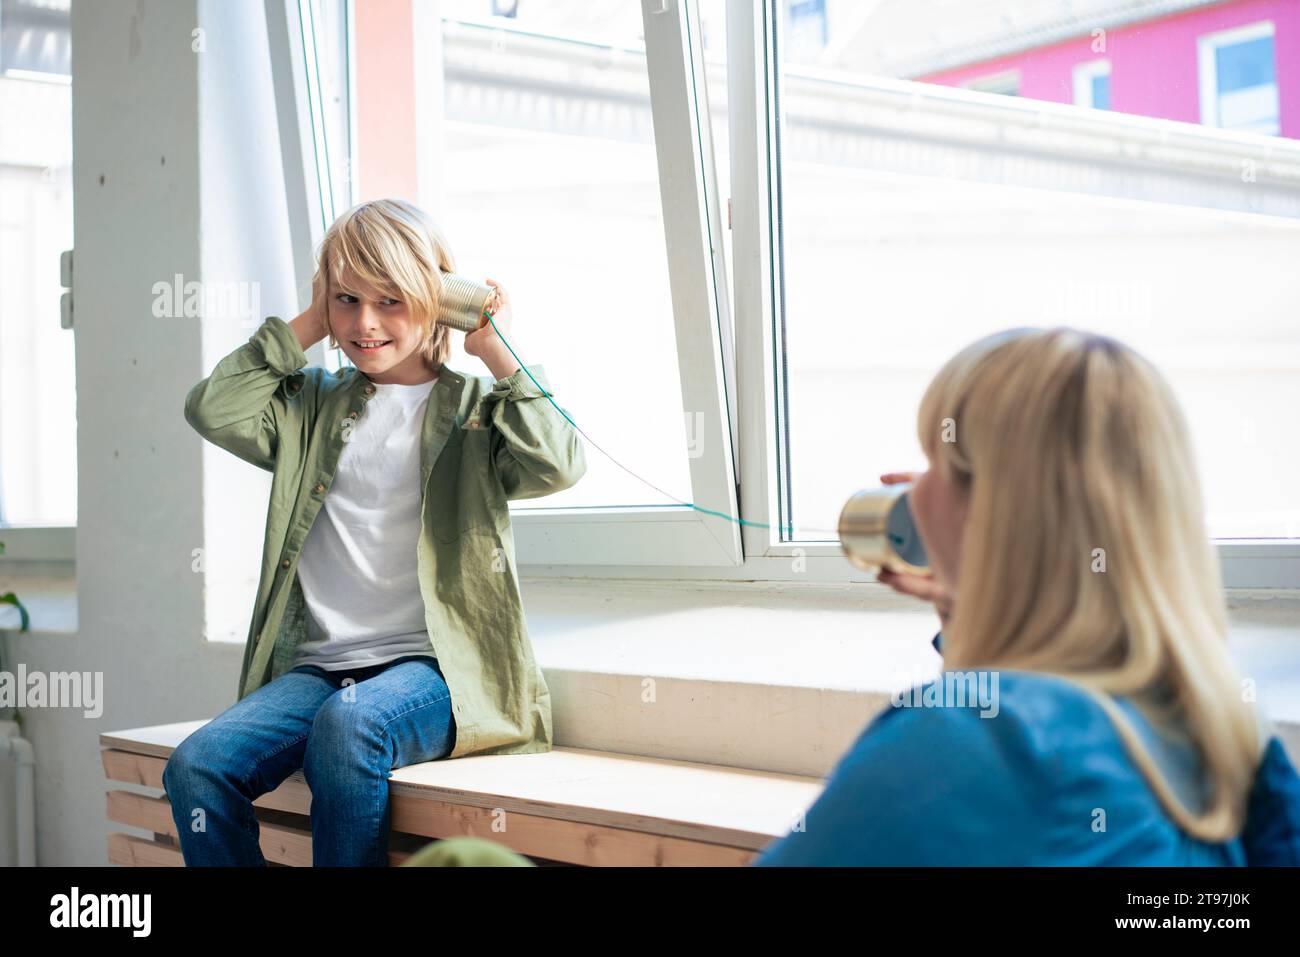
[340,0,692,508]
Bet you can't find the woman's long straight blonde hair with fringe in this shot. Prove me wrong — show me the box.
[918,328,1261,843]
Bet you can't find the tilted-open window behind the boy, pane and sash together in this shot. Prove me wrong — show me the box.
[300,0,740,563]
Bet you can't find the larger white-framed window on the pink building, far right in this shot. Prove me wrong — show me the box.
[1199,23,1281,135]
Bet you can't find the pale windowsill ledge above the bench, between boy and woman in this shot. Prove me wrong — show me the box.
[523,577,1300,776]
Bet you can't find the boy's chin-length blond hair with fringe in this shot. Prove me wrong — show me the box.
[315,199,456,369]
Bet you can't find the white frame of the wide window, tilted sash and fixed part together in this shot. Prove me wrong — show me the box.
[267,0,1300,588]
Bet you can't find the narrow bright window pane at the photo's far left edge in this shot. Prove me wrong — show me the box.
[0,0,77,525]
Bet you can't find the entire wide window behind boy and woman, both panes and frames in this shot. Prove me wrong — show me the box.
[271,0,1300,585]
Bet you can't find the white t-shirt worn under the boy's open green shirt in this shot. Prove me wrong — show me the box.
[294,378,437,671]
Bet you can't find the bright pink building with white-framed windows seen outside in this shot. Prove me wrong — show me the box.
[911,0,1300,138]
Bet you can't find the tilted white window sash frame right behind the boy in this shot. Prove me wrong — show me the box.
[491,0,744,566]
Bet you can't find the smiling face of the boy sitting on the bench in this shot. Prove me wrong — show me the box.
[328,272,433,385]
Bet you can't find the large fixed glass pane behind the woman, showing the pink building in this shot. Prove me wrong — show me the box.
[781,0,1300,540]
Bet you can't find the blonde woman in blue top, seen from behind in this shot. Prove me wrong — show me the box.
[757,329,1300,865]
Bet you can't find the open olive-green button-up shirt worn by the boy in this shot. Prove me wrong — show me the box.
[185,316,586,758]
